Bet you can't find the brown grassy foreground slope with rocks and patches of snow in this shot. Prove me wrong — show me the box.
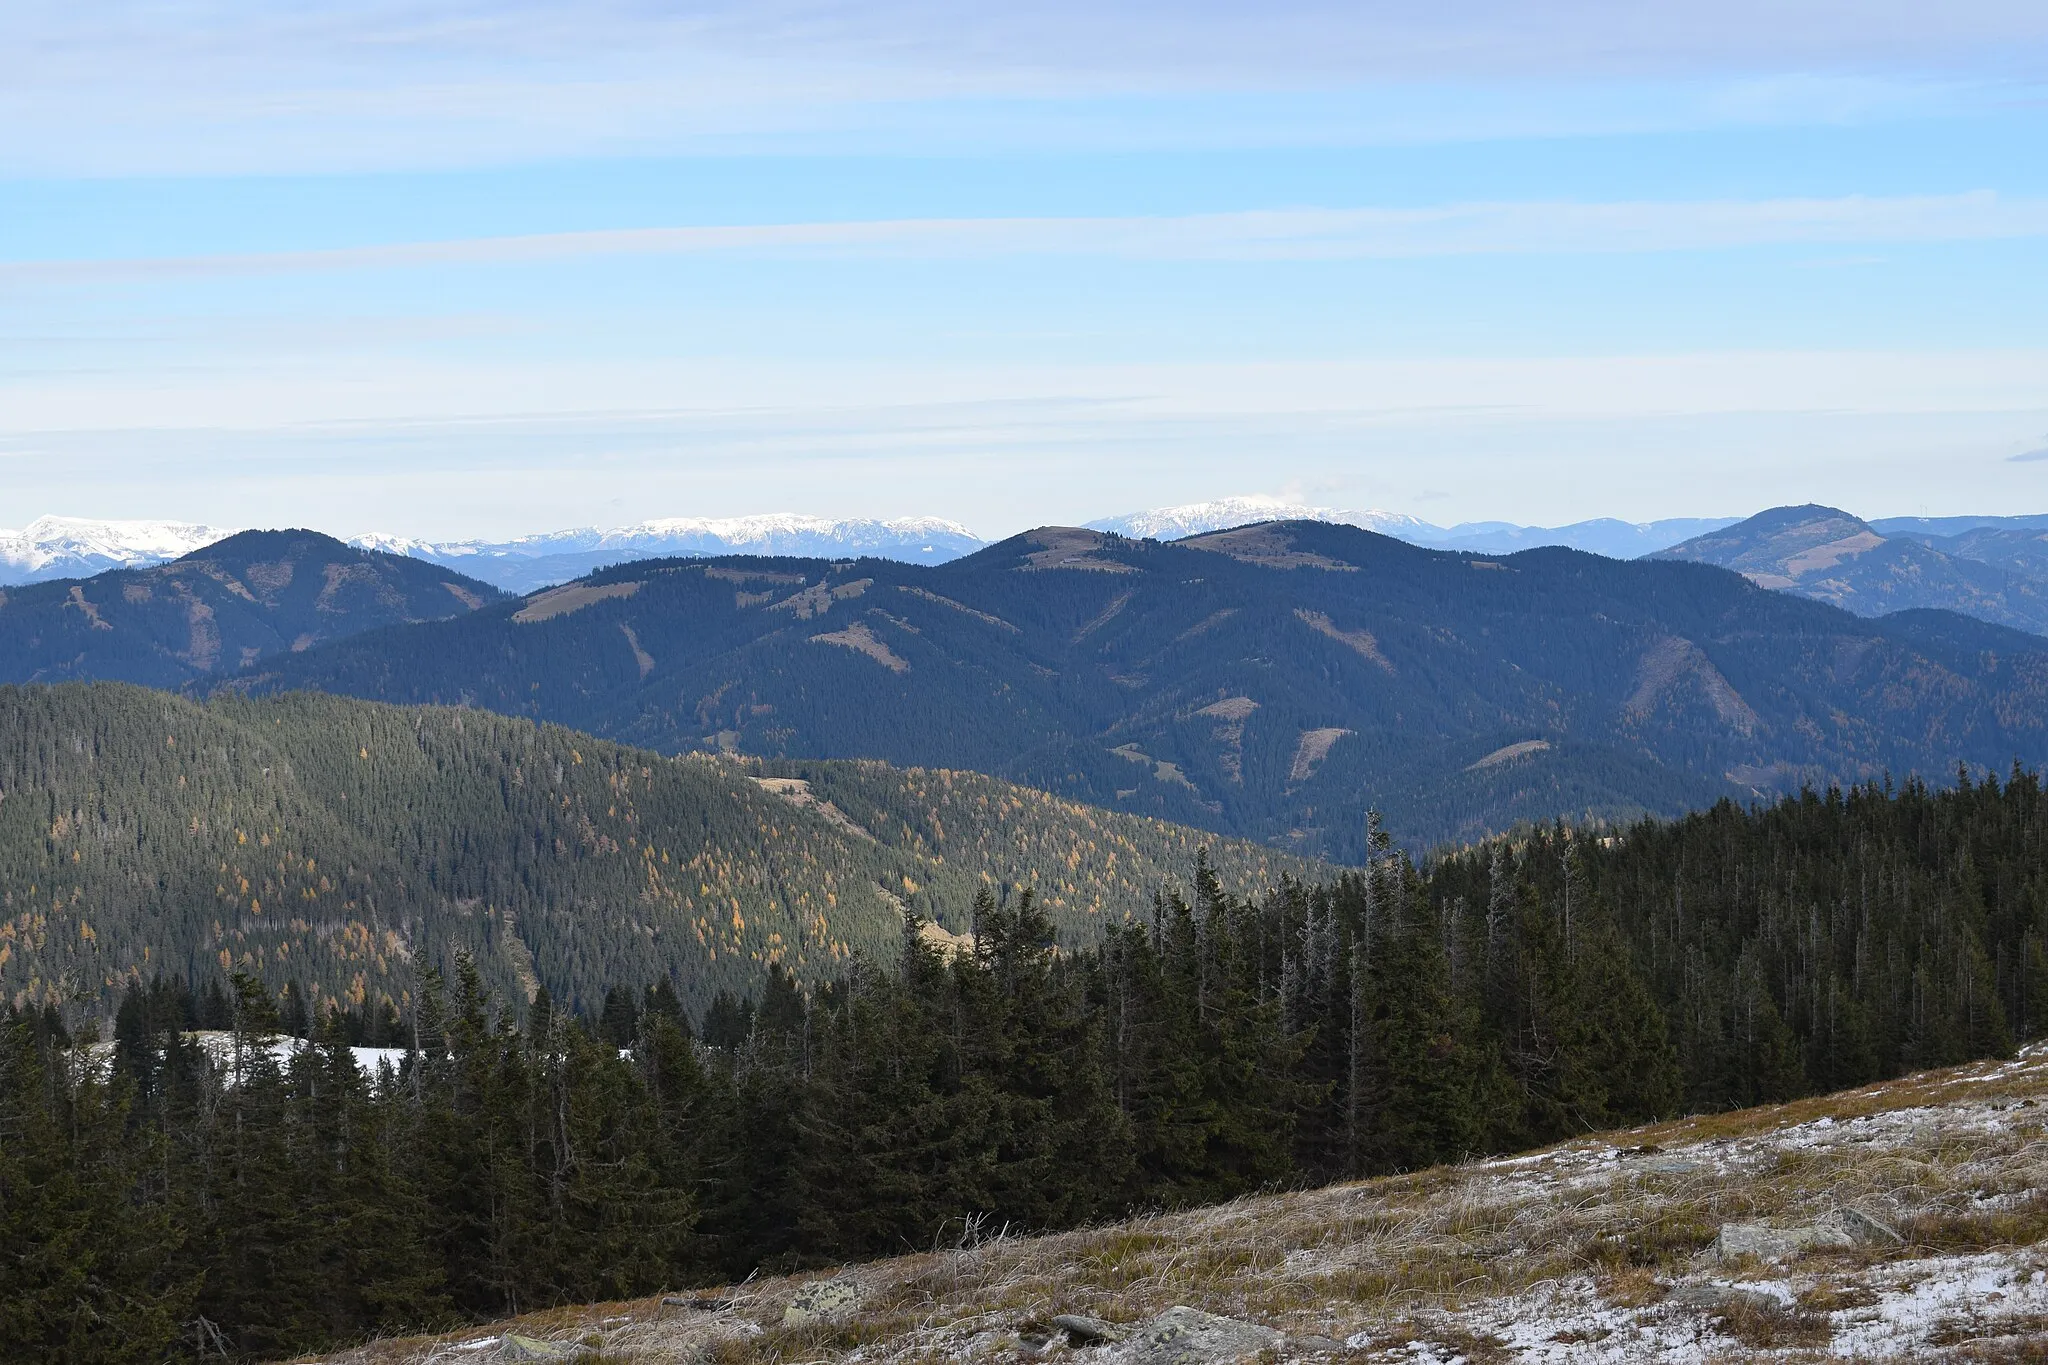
[307,1046,2048,1365]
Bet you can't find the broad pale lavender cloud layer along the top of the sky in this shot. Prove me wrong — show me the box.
[0,0,2048,174]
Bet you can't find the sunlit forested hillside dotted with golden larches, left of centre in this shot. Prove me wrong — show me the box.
[0,684,1319,1009]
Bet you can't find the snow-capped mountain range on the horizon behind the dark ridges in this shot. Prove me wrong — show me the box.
[0,495,1916,593]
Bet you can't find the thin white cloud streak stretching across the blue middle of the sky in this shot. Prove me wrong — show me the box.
[0,190,2048,284]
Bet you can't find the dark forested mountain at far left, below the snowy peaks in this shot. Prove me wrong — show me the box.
[0,530,504,688]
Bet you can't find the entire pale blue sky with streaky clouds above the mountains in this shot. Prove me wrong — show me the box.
[0,0,2048,538]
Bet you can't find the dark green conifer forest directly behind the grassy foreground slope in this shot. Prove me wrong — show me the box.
[0,769,2048,1365]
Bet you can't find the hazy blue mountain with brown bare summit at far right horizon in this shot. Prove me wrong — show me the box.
[1657,503,2048,634]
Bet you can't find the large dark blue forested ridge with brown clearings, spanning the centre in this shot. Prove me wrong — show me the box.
[238,522,2048,862]
